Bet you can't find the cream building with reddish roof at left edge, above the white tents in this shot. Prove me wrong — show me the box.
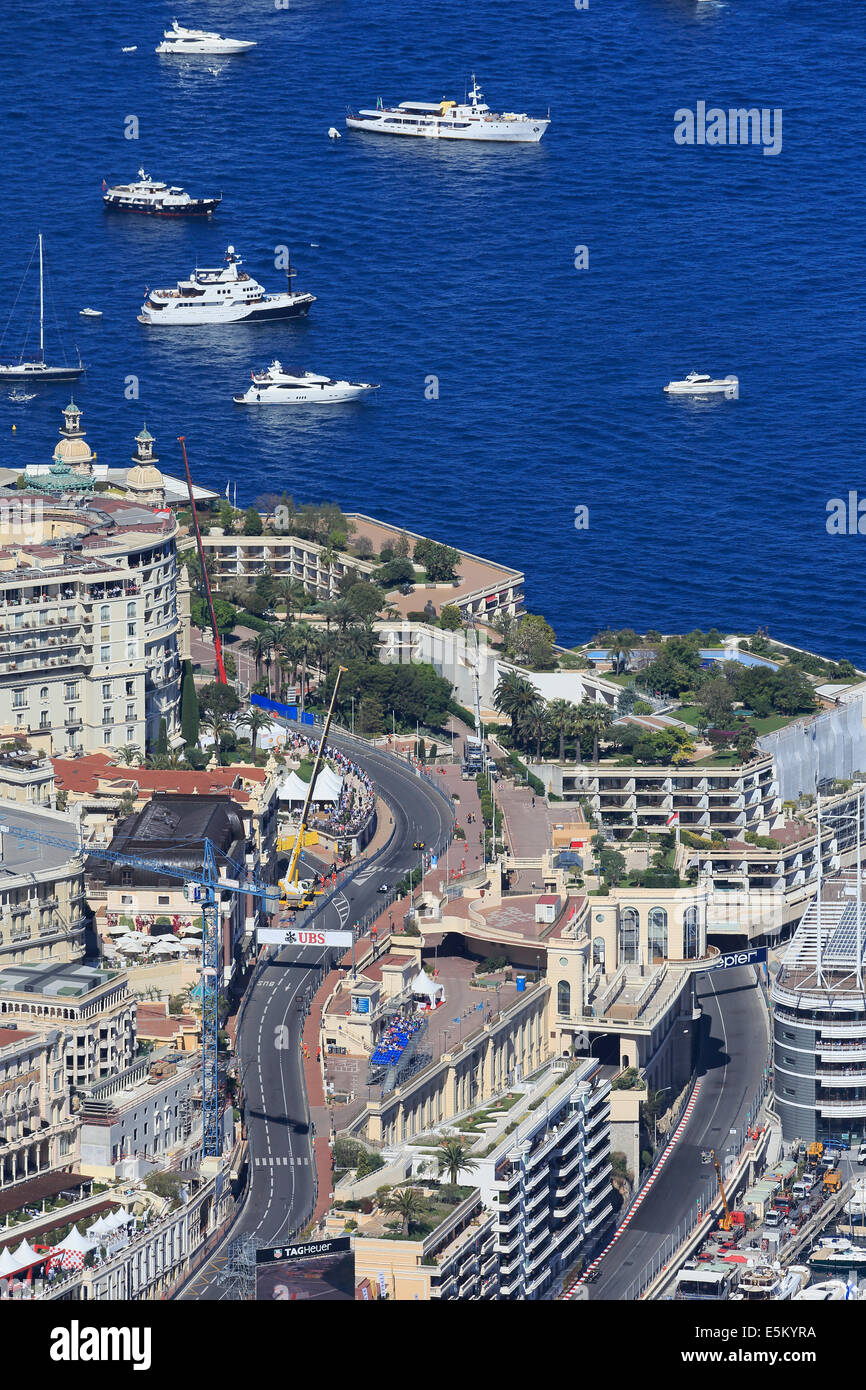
[0,1026,78,1191]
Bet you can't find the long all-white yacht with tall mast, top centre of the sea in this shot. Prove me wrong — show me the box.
[346,72,550,145]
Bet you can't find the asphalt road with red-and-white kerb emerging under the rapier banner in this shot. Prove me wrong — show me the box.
[589,966,769,1301]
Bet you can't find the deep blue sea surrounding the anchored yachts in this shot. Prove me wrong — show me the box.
[0,0,866,664]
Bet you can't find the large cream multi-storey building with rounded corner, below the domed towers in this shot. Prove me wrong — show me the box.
[0,493,189,753]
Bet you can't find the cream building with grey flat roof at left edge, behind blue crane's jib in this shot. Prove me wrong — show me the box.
[0,806,88,970]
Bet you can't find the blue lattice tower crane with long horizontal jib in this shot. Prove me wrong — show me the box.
[0,824,279,1158]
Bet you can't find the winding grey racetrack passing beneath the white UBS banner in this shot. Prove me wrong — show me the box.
[179,726,453,1300]
